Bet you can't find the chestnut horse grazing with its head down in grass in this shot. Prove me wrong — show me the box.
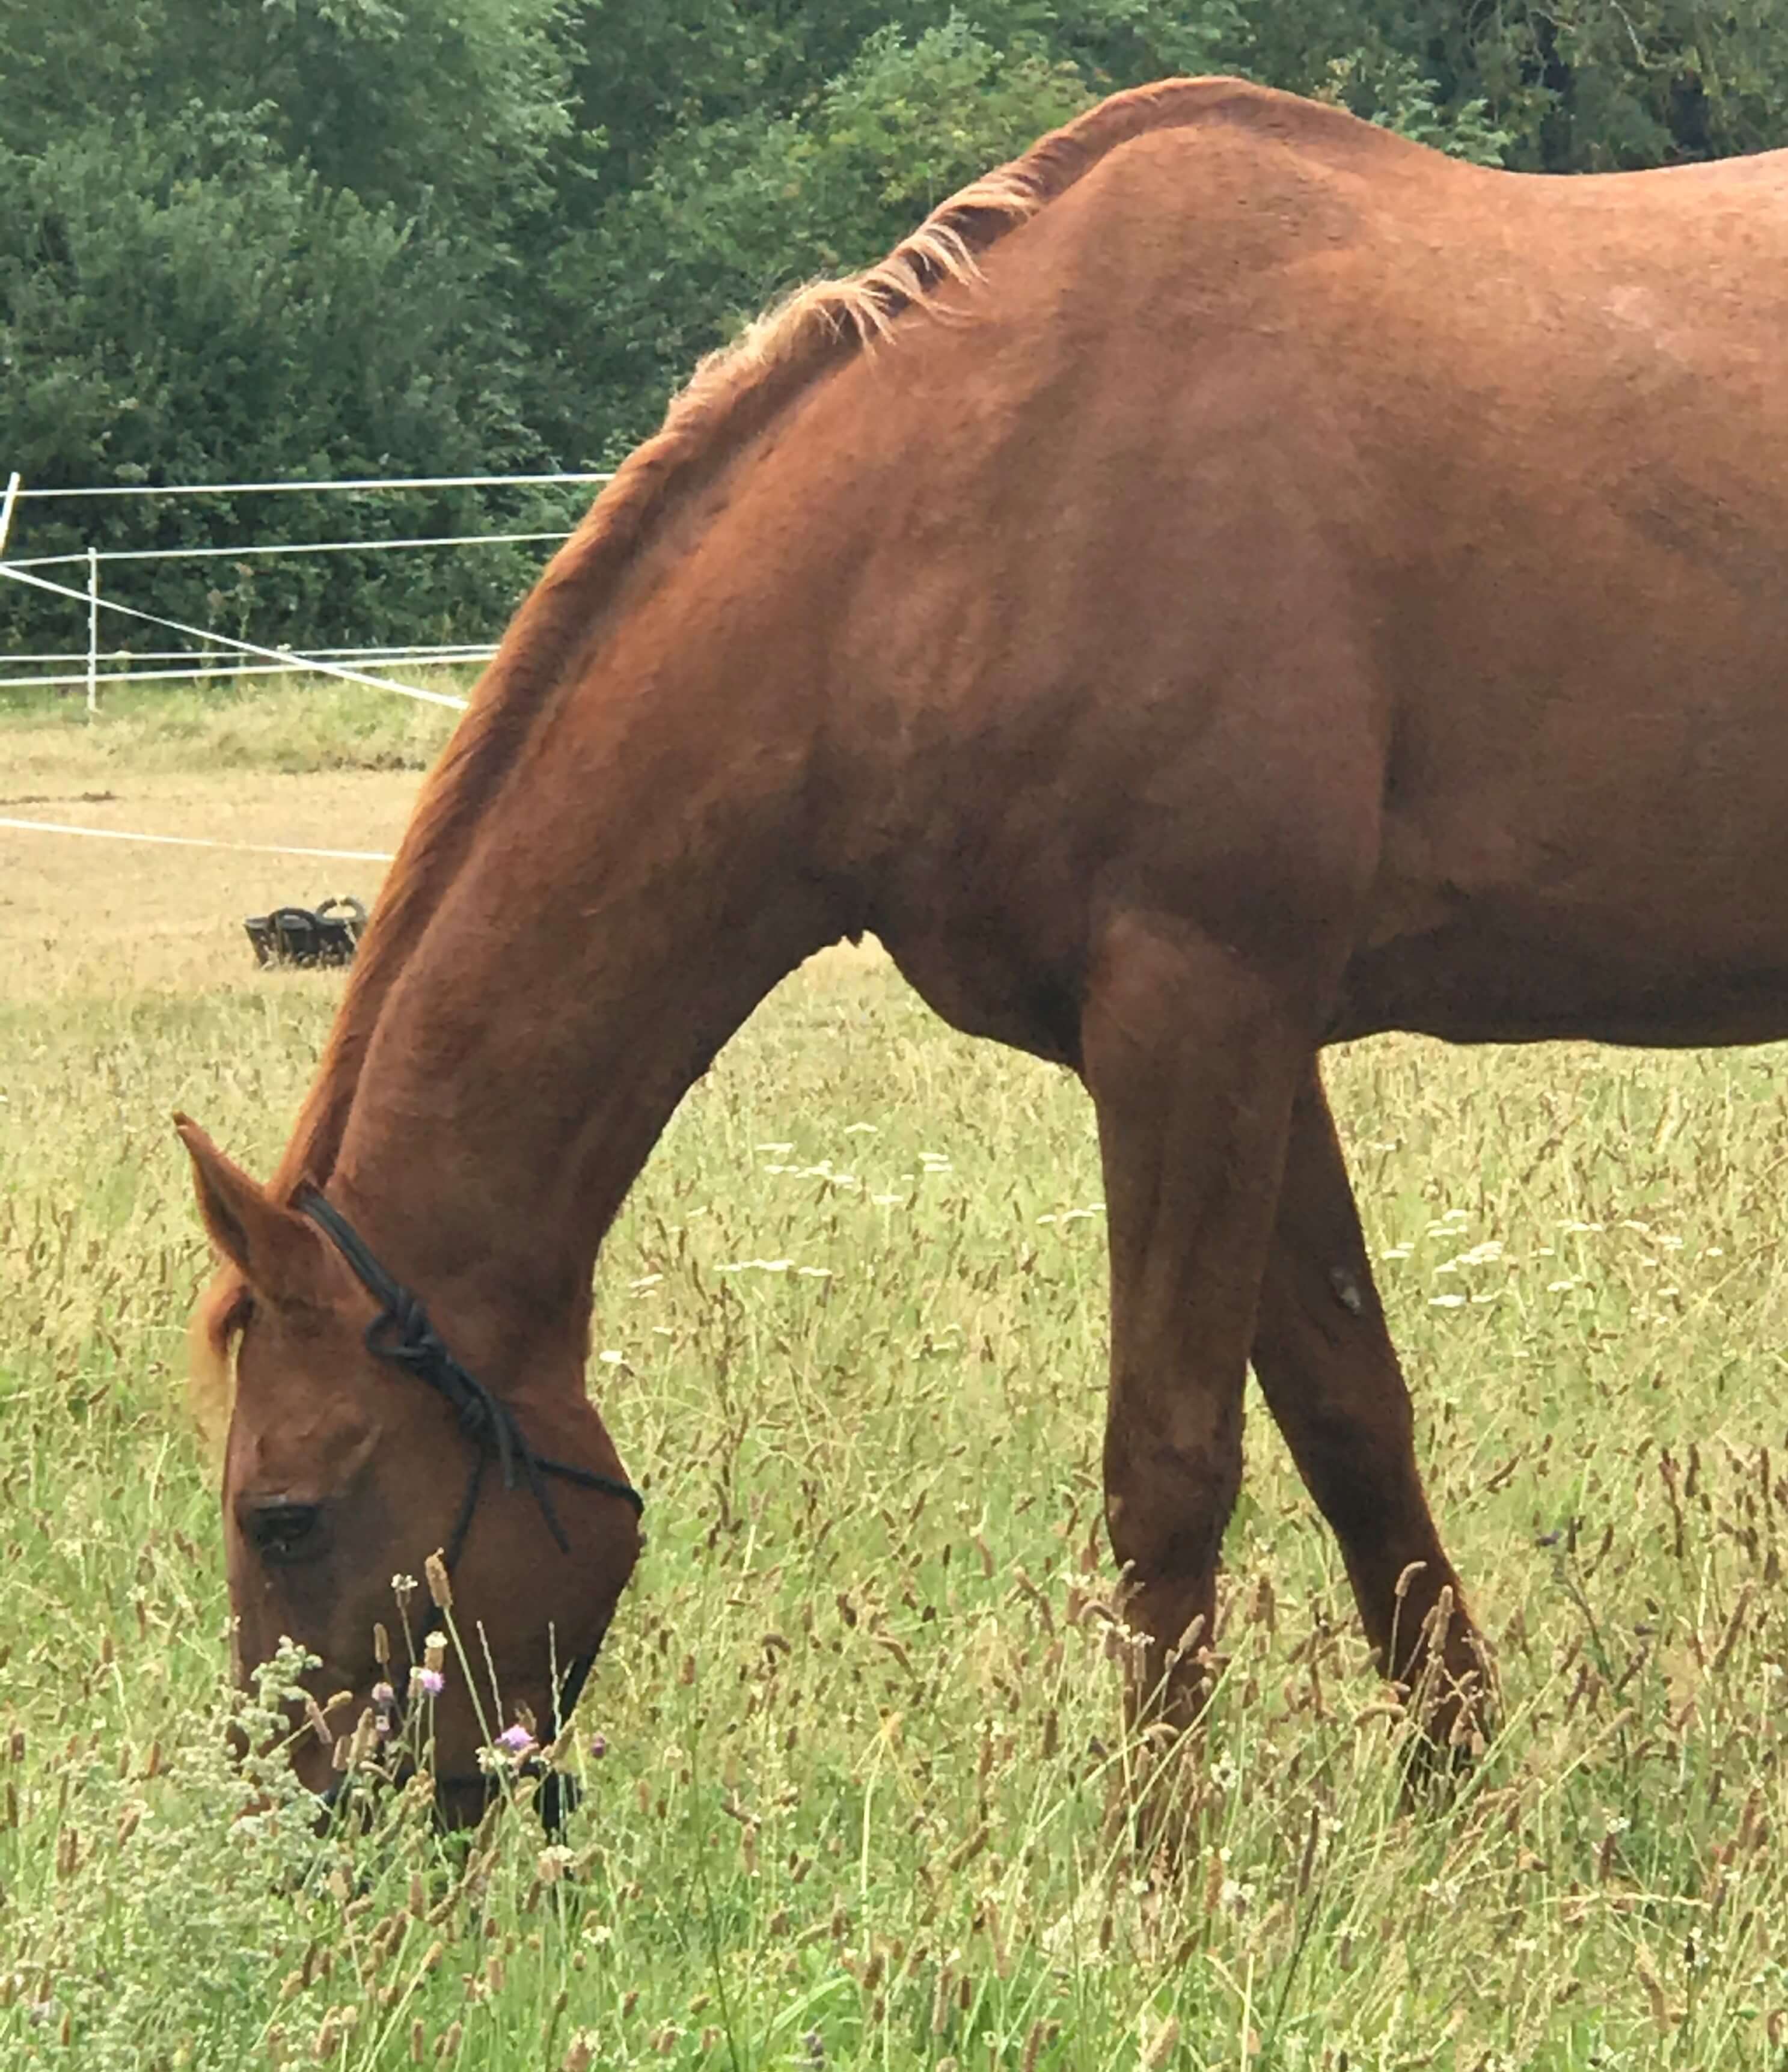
[182,79,1788,1806]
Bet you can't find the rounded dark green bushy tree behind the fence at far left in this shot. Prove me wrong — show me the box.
[0,108,563,646]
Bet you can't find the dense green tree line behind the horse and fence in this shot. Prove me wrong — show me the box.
[0,0,1788,640]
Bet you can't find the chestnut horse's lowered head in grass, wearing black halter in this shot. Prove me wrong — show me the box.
[178,1117,638,1817]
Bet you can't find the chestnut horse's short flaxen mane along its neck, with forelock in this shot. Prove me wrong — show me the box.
[189,79,1332,1434]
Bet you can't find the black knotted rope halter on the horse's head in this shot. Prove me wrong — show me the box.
[294,1185,646,1827]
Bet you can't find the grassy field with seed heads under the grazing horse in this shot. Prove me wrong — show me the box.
[0,688,1788,2072]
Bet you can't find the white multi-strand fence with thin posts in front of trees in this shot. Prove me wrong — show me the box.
[0,470,611,713]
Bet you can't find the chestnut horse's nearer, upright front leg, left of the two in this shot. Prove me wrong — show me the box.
[1082,916,1314,1730]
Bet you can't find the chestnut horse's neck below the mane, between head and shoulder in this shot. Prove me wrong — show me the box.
[323,576,850,1351]
